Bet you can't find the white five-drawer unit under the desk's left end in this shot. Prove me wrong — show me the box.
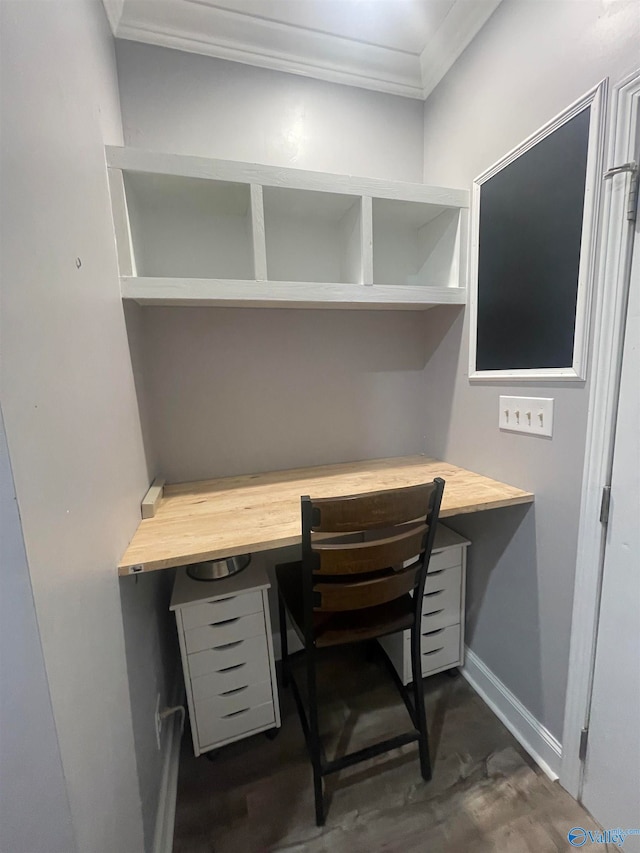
[171,565,280,755]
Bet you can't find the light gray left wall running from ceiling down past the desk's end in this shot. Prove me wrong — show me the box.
[0,0,175,853]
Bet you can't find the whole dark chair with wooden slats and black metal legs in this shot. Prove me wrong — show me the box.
[276,478,444,826]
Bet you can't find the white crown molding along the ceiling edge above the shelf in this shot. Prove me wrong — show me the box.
[111,0,501,100]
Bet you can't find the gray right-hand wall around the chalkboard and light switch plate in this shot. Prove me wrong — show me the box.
[424,0,640,739]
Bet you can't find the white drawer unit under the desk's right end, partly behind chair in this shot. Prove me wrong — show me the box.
[378,524,470,684]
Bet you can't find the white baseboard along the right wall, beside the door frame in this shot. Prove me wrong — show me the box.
[460,648,562,782]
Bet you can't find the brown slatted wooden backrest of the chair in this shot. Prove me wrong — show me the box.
[301,478,444,628]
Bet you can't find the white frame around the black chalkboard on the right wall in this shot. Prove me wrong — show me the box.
[469,80,607,381]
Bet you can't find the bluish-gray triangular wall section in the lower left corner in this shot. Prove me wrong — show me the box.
[0,411,77,853]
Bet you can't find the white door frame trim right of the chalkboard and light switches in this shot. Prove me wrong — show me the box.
[560,69,640,799]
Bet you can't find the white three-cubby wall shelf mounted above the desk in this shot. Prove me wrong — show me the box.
[107,147,469,309]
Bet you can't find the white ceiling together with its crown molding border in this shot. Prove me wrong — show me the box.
[104,0,500,99]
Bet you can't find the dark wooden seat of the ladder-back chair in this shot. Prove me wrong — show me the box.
[276,561,414,649]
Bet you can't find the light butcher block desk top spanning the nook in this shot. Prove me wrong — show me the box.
[118,456,533,575]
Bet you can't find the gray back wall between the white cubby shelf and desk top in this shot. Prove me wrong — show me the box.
[135,308,459,482]
